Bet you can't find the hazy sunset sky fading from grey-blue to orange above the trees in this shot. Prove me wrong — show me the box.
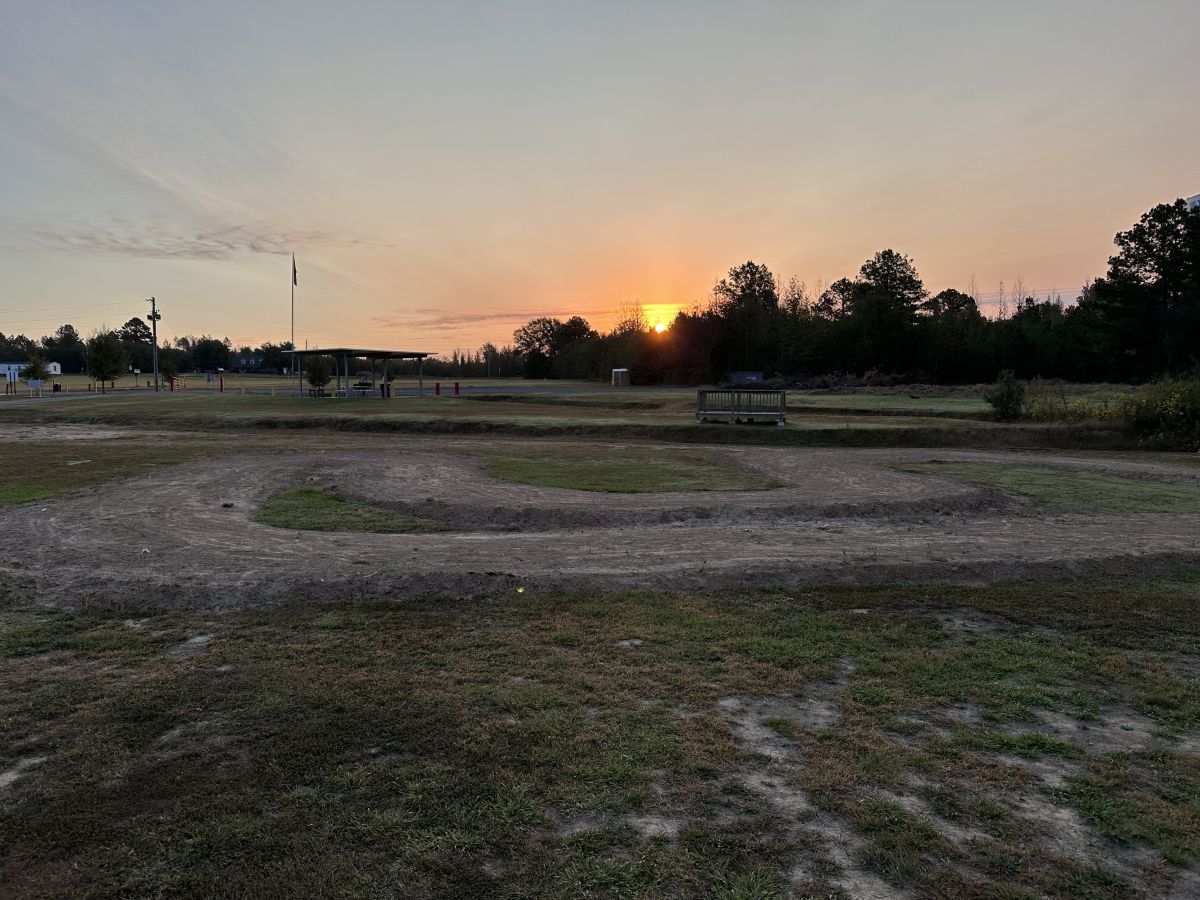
[0,0,1200,354]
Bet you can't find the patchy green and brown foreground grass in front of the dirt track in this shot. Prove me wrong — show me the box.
[0,575,1200,898]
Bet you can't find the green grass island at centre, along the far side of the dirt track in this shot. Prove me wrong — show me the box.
[487,449,780,493]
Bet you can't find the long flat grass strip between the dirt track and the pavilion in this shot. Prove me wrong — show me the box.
[0,392,1136,449]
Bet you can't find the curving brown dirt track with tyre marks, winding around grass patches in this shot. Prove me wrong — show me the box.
[0,434,1200,608]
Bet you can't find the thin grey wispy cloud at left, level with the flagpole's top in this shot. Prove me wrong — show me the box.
[0,221,388,259]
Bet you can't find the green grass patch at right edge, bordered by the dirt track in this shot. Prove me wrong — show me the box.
[895,462,1200,514]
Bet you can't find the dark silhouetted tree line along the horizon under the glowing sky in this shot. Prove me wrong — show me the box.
[0,200,1200,384]
